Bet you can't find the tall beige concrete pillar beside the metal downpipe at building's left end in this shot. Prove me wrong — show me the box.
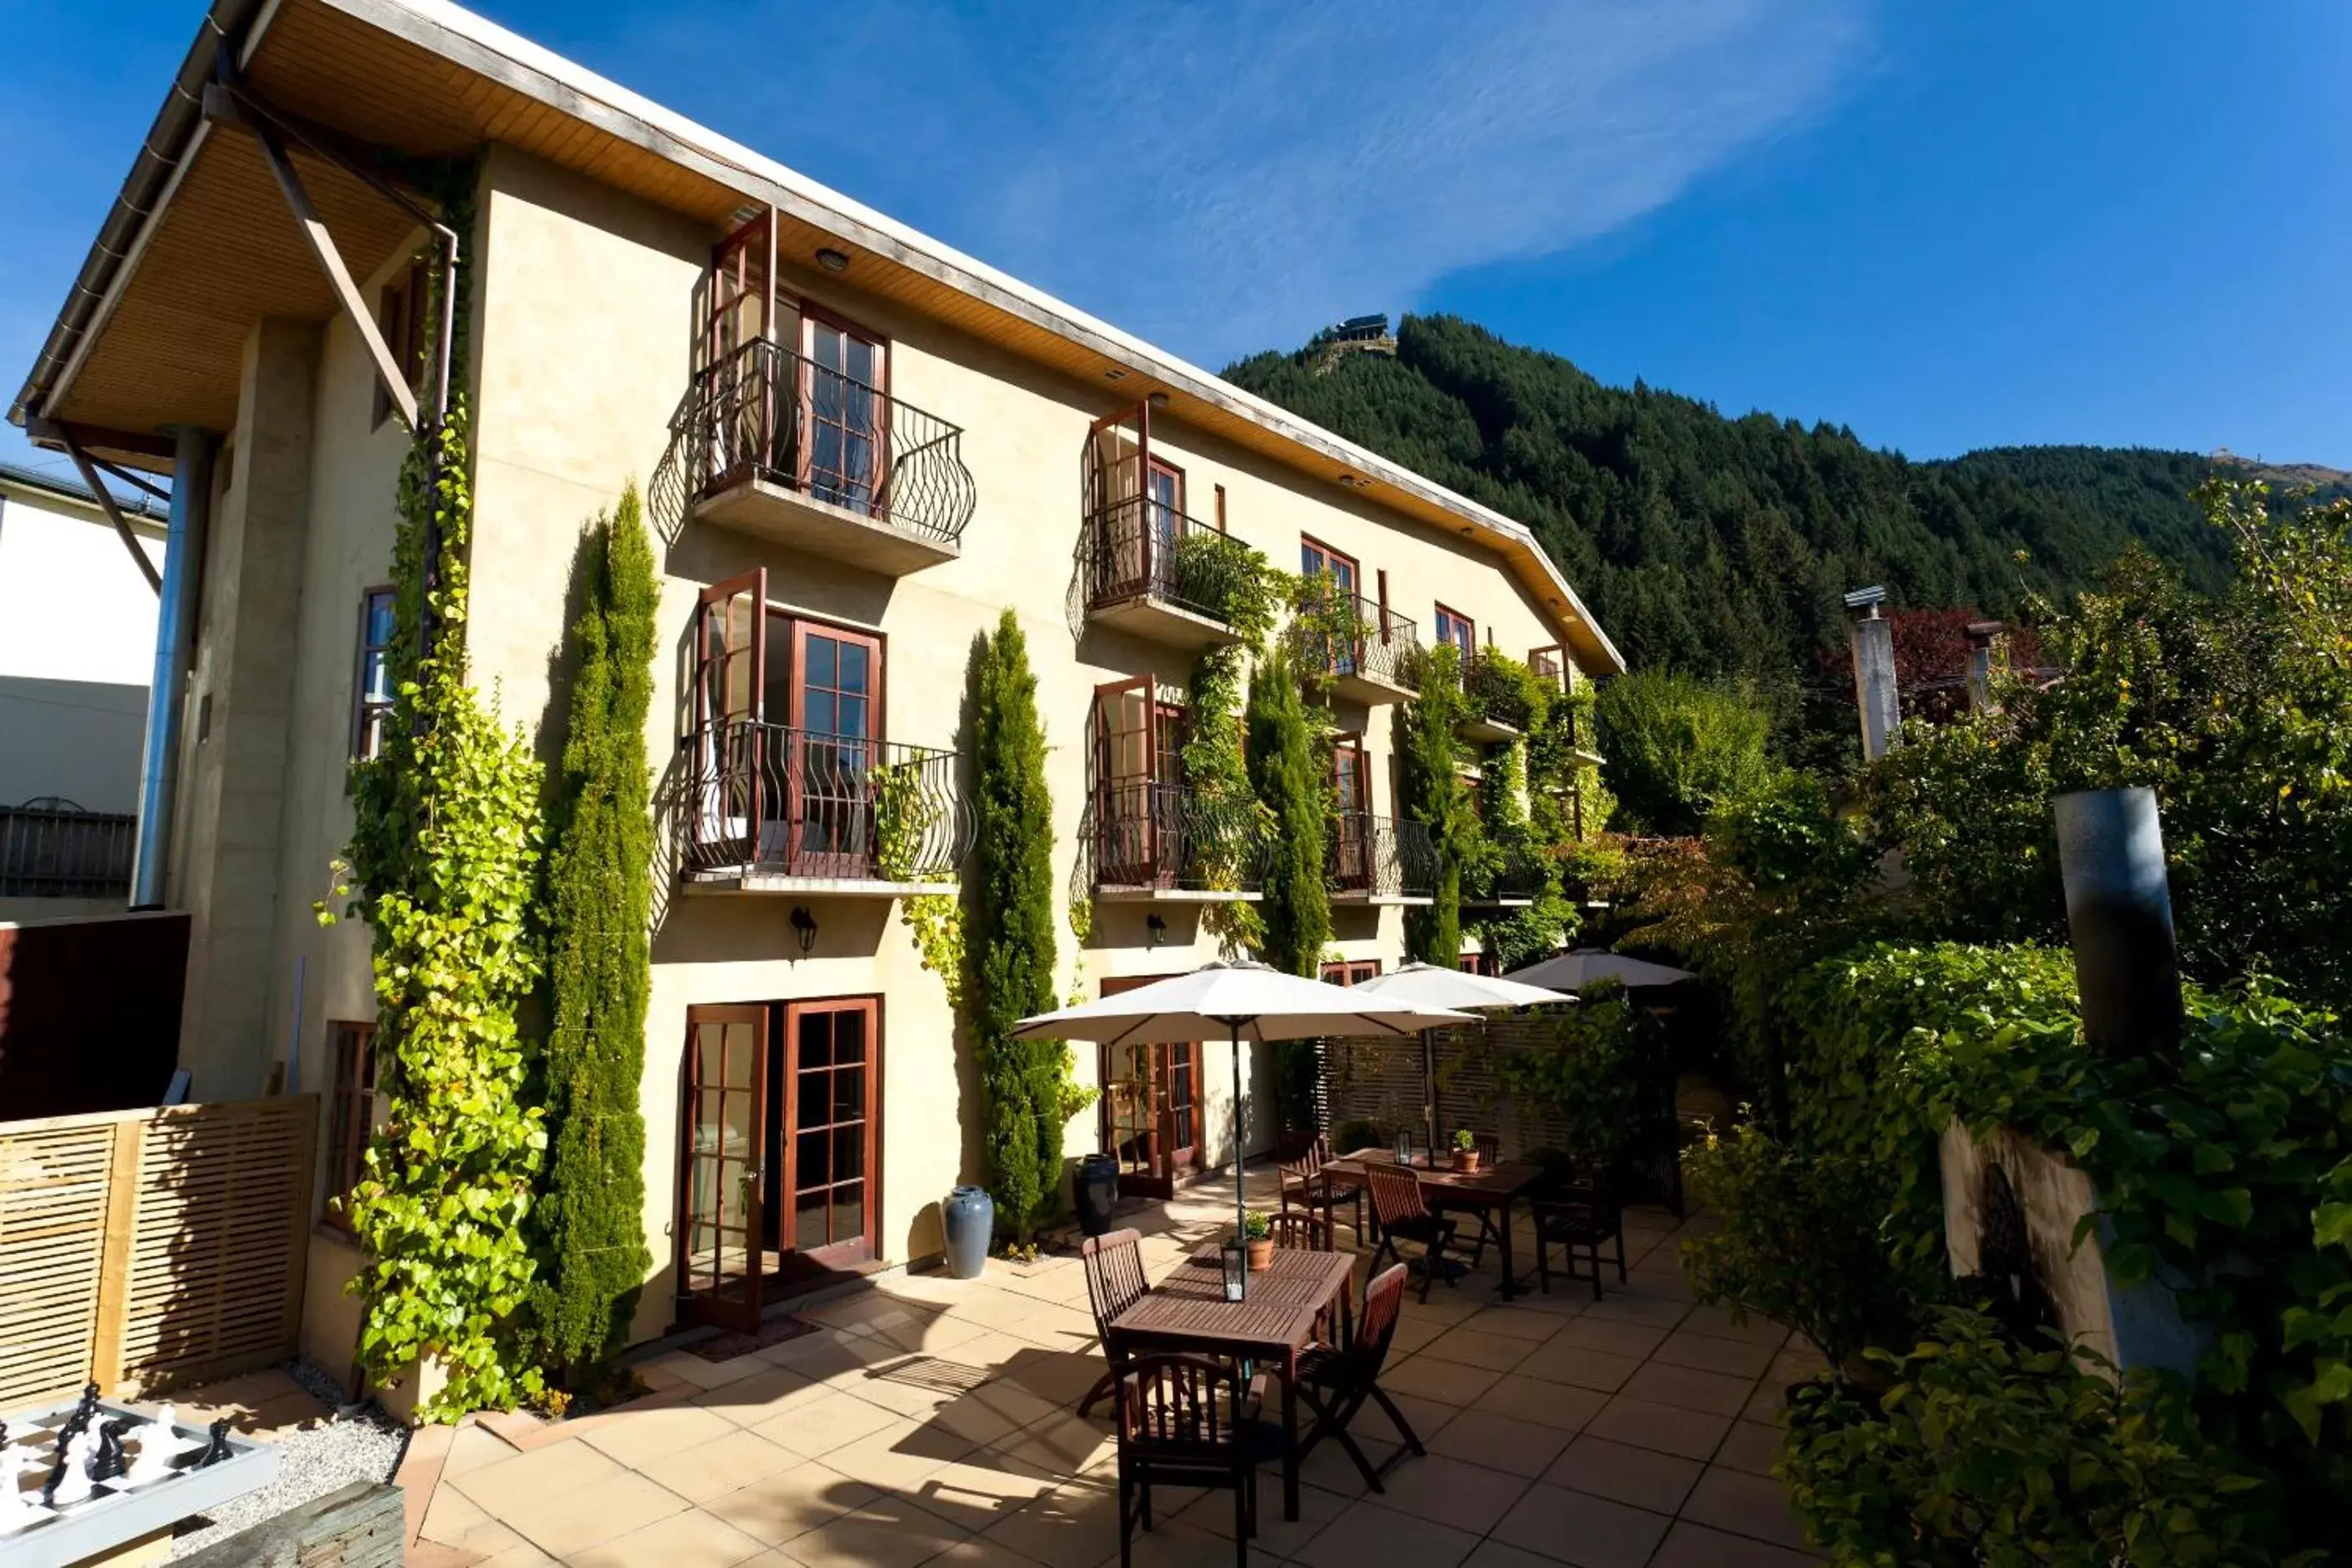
[178,317,320,1100]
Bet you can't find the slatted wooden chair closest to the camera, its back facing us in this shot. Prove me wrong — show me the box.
[1117,1354,1258,1568]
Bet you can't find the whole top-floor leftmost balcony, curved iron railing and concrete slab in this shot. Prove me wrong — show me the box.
[652,338,978,576]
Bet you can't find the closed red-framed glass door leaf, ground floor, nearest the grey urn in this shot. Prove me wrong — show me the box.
[786,997,879,1267]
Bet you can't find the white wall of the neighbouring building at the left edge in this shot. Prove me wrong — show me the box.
[0,463,165,813]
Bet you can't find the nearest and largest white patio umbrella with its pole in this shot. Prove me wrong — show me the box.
[1014,964,1470,1227]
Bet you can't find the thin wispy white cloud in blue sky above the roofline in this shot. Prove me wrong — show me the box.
[574,0,1865,364]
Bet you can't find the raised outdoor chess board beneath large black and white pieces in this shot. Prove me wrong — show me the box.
[0,1399,277,1568]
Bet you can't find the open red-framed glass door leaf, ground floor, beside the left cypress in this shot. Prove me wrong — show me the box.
[678,1006,766,1331]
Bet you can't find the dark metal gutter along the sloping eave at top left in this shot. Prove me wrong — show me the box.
[7,0,277,441]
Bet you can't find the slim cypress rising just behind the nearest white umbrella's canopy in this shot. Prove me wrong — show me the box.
[1249,647,1331,980]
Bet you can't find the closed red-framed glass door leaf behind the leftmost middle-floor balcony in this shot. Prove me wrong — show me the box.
[786,621,882,877]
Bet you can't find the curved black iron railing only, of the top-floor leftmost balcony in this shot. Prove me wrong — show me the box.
[656,338,978,545]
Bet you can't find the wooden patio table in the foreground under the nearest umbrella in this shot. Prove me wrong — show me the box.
[1106,1246,1354,1519]
